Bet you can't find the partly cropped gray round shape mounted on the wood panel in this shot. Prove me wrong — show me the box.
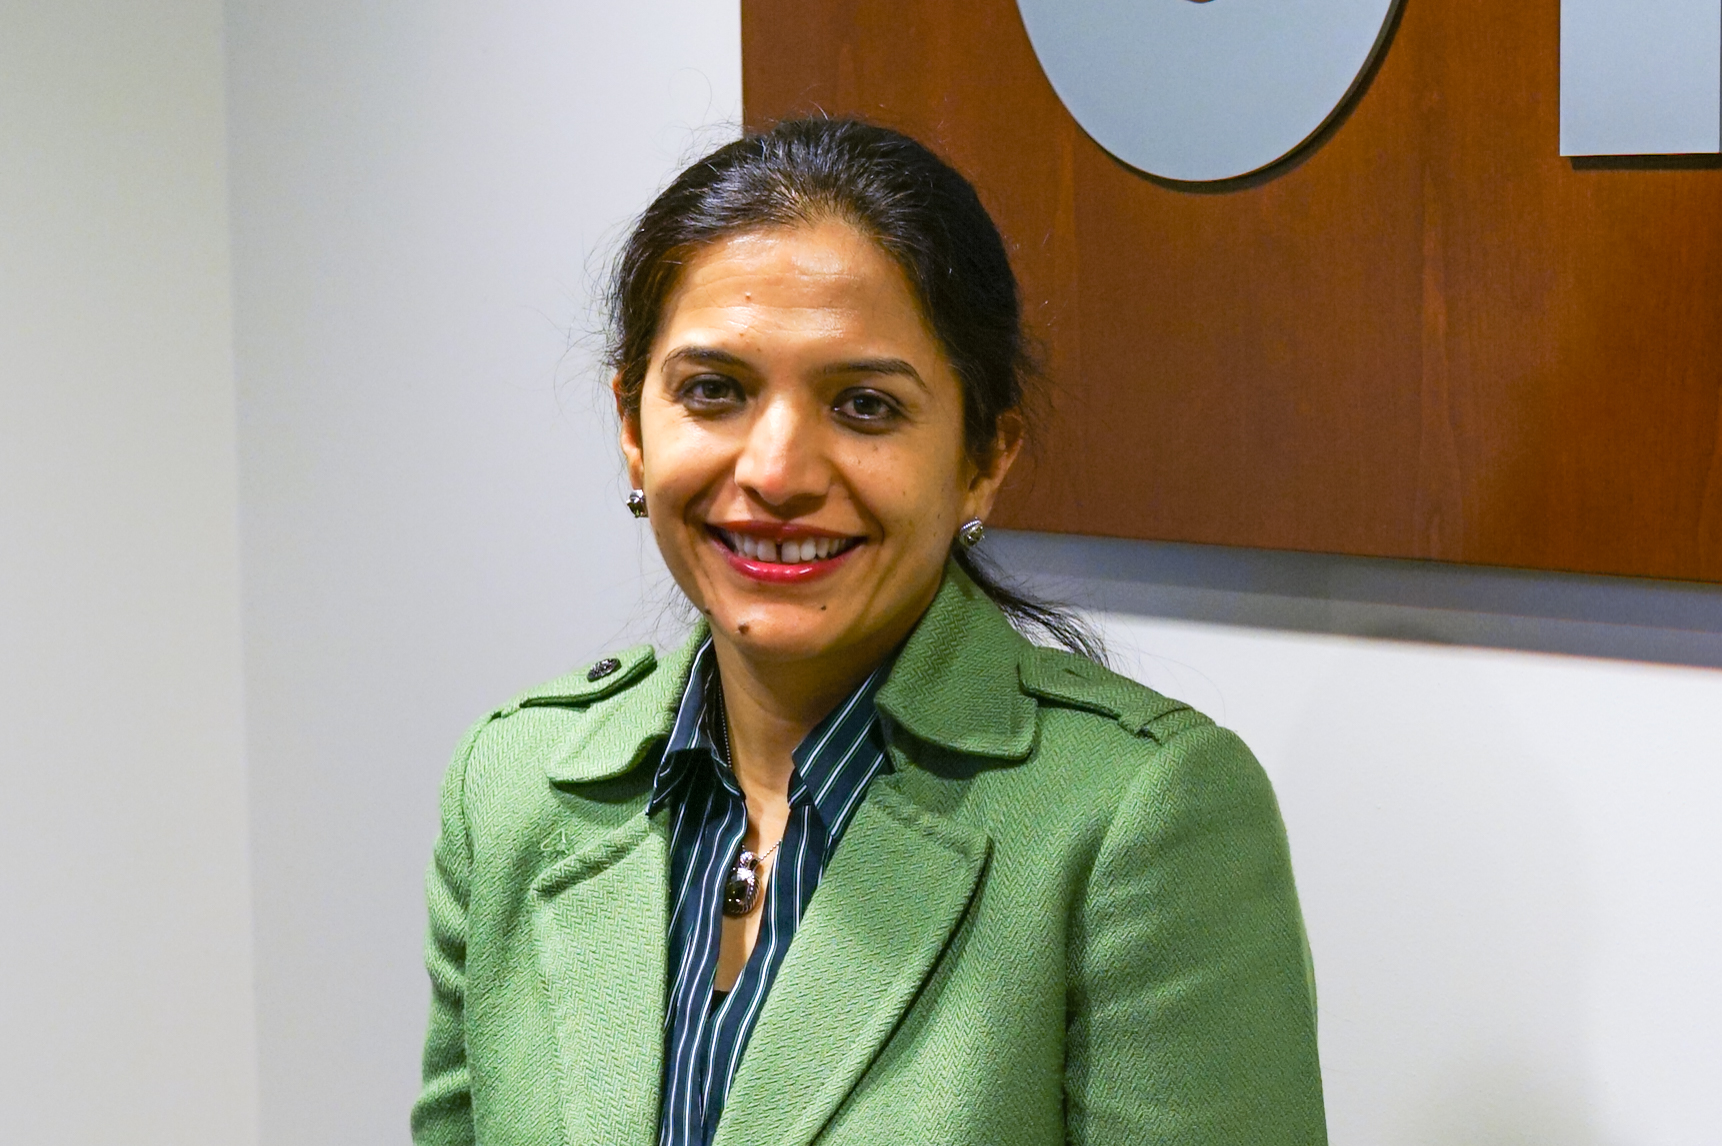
[1018,0,1397,182]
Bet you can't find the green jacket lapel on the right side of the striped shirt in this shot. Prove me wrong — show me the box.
[713,776,990,1146]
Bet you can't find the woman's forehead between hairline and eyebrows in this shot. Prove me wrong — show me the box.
[654,222,942,358]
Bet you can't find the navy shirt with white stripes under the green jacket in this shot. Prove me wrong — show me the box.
[646,638,890,1146]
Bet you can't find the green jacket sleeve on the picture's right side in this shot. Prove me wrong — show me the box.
[1066,711,1328,1146]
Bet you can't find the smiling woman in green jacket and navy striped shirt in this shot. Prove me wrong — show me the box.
[413,120,1324,1146]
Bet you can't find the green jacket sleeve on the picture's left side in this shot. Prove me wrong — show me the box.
[412,724,482,1146]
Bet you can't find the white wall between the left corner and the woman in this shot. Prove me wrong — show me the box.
[229,0,740,1146]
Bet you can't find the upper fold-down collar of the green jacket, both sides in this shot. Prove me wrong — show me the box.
[544,561,1037,783]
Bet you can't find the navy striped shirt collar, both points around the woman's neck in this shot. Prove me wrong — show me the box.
[646,635,892,826]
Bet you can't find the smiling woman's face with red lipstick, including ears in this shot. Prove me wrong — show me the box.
[622,222,1019,669]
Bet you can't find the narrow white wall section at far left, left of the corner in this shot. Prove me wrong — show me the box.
[0,0,257,1146]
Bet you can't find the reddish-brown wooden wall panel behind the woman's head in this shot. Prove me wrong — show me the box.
[742,0,1722,580]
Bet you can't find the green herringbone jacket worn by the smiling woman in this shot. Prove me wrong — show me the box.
[413,566,1326,1146]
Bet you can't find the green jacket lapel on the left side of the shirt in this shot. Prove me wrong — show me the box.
[532,816,668,1146]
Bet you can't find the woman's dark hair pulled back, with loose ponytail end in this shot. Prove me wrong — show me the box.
[608,119,1104,661]
